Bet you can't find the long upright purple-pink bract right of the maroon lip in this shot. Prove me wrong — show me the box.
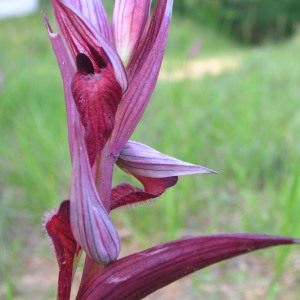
[109,0,173,155]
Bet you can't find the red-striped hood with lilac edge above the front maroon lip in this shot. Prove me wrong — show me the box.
[52,0,127,91]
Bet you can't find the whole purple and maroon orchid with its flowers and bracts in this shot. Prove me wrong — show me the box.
[44,0,297,299]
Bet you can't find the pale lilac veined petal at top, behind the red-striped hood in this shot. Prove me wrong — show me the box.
[71,0,113,45]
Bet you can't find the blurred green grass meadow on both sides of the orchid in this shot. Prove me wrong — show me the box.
[0,2,300,299]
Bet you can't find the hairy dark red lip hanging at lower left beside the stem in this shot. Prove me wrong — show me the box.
[45,201,78,300]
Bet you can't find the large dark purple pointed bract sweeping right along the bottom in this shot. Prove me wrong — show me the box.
[76,233,300,300]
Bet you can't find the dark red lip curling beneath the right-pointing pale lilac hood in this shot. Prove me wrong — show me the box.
[110,176,178,210]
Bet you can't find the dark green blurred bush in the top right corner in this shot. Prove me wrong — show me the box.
[174,0,300,44]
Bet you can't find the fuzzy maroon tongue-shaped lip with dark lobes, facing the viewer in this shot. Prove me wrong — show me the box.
[72,49,122,166]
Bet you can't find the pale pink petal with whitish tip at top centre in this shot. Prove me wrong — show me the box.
[112,0,151,66]
